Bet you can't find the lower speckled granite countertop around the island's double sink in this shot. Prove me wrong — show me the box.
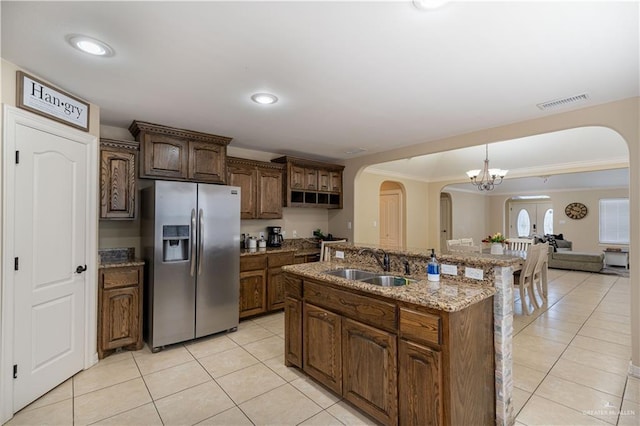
[282,262,496,312]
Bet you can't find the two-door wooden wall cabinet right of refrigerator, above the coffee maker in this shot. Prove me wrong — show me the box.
[227,157,284,219]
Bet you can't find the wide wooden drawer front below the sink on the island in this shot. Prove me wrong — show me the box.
[304,281,398,333]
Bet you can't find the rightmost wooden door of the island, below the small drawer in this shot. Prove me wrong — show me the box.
[398,339,443,426]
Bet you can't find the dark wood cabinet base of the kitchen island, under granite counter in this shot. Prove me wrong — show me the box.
[285,273,495,426]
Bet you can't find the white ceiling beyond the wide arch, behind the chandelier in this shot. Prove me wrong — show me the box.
[366,127,629,195]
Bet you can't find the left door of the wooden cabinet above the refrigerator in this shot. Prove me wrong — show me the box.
[140,133,189,179]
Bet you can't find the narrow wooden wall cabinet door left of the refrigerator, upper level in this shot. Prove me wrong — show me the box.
[100,149,136,219]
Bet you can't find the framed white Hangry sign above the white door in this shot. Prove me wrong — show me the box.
[16,71,89,132]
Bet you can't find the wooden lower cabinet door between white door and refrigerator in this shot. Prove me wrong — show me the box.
[100,286,140,351]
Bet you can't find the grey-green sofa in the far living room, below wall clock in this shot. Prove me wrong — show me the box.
[536,234,604,272]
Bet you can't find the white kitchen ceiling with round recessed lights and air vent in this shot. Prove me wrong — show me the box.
[0,1,640,164]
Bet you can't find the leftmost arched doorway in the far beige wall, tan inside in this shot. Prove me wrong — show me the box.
[379,181,406,249]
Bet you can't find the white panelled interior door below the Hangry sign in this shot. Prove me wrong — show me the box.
[2,105,97,415]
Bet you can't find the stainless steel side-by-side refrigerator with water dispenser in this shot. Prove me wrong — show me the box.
[140,181,240,352]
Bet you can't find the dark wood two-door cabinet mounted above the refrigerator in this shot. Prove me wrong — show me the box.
[129,121,231,184]
